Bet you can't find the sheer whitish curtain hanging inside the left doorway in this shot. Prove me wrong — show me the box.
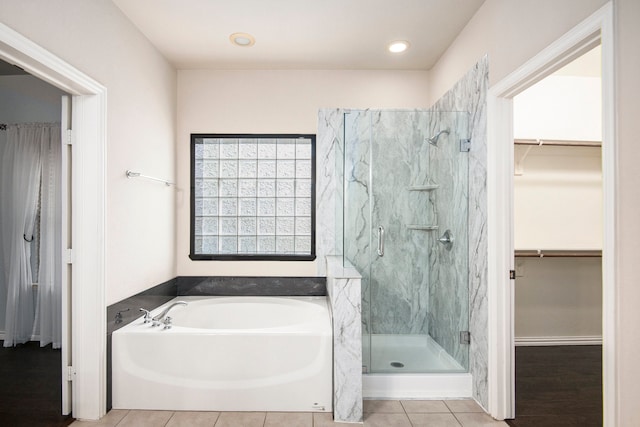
[0,124,61,347]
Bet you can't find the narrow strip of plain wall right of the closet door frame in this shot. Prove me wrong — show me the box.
[614,0,640,427]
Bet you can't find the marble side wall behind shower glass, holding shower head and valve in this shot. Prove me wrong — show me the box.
[428,112,469,369]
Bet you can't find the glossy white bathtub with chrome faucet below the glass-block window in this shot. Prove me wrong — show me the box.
[112,297,332,412]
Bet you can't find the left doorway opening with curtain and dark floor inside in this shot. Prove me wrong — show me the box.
[0,61,71,425]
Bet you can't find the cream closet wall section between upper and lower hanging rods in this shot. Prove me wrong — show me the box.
[514,146,603,250]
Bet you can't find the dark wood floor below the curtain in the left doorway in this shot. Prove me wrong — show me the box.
[0,341,73,427]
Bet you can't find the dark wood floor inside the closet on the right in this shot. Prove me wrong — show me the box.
[507,346,602,427]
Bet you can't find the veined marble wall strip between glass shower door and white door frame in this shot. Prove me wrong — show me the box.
[432,56,489,408]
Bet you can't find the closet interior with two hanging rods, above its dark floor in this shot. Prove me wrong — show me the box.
[514,47,603,345]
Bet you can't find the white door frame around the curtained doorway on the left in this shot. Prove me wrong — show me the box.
[0,23,107,420]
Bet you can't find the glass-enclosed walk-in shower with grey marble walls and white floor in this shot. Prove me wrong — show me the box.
[341,110,469,388]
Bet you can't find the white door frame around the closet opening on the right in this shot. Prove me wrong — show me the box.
[487,2,617,427]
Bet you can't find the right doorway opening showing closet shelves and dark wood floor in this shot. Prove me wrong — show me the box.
[508,46,603,427]
